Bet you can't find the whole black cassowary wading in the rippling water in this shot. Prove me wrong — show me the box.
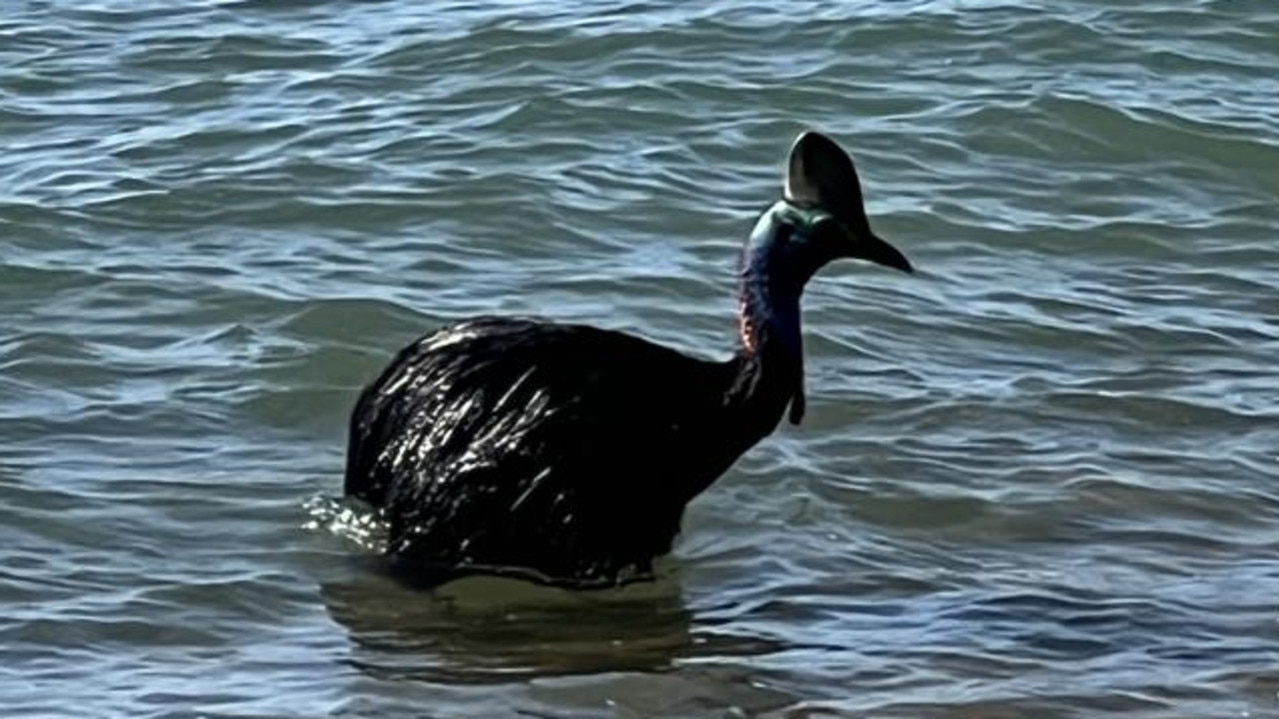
[345,132,912,587]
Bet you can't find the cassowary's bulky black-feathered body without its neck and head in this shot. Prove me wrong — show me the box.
[347,317,785,585]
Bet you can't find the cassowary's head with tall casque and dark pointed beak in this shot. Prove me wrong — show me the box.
[748,130,914,290]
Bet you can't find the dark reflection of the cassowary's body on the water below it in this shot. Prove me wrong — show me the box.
[321,568,693,683]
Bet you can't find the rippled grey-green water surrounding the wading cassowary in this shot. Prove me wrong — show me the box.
[0,0,1279,719]
